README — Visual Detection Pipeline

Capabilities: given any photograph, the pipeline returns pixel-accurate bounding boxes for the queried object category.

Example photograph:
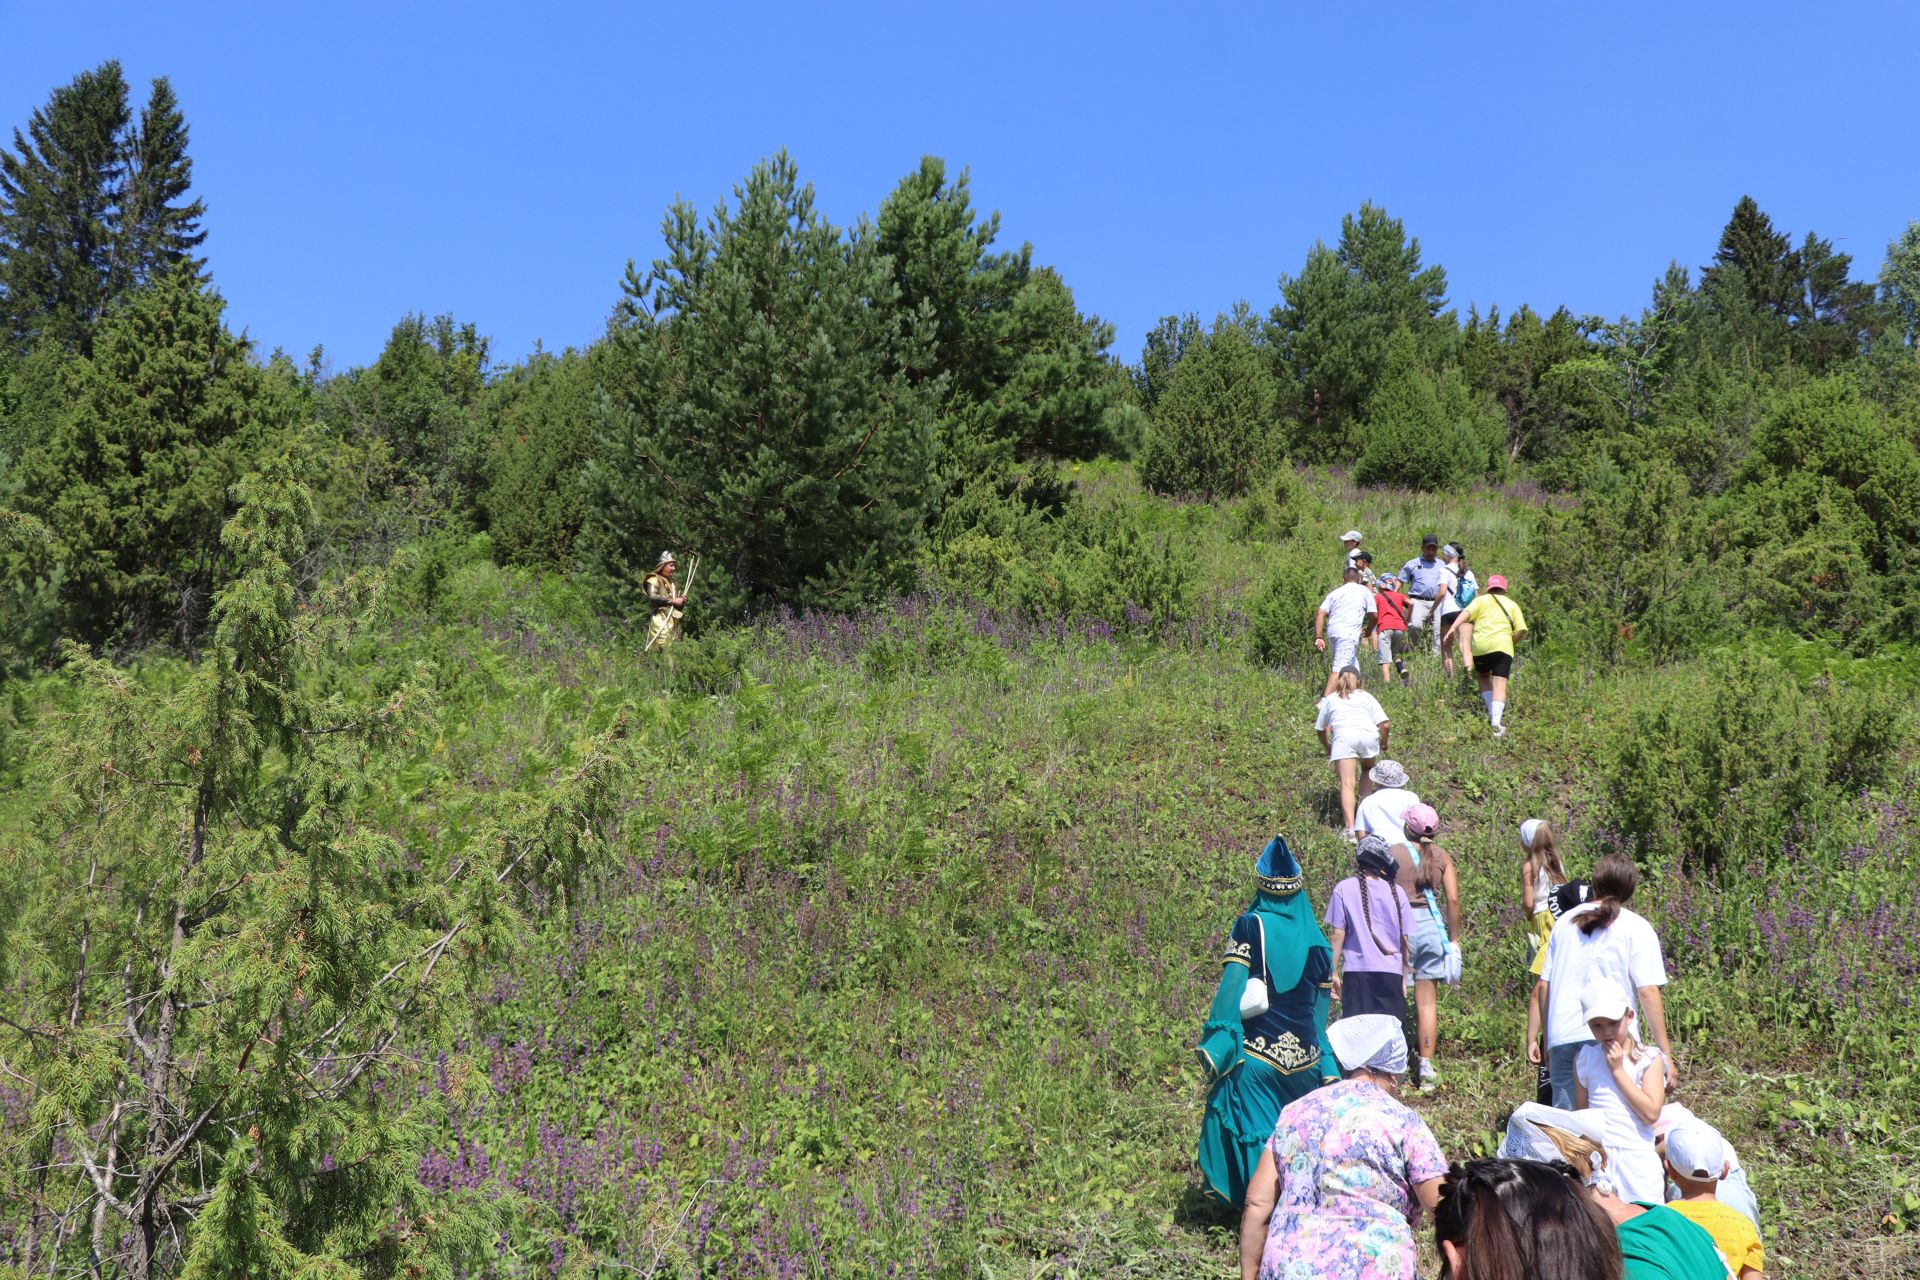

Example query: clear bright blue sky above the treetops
[0,0,1920,368]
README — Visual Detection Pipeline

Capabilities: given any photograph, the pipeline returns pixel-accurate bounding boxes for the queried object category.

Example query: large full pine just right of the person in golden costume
[588,152,945,618]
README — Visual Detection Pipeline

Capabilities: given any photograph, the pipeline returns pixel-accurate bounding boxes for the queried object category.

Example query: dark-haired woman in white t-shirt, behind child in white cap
[1526,854,1678,1111]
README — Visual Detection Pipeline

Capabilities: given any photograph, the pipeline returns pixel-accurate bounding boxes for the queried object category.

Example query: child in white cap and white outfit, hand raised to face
[1572,977,1667,1205]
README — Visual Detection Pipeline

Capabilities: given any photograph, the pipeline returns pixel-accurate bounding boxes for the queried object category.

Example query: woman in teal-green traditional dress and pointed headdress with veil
[1194,835,1340,1207]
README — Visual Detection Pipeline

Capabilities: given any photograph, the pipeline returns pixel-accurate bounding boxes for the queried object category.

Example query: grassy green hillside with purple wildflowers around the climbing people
[0,468,1920,1276]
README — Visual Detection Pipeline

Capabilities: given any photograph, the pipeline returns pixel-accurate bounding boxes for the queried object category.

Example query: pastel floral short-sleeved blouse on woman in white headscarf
[1260,1080,1446,1280]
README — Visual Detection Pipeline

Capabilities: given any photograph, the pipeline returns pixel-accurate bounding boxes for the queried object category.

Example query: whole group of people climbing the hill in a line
[1198,530,1763,1280]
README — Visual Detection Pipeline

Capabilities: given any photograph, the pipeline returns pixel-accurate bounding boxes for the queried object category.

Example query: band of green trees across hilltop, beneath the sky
[0,63,1920,664]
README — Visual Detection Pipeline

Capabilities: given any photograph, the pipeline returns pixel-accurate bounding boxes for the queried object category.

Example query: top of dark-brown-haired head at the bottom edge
[1434,1159,1620,1280]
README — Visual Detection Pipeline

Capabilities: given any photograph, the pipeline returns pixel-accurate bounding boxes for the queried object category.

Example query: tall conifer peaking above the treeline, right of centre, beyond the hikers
[1269,203,1452,449]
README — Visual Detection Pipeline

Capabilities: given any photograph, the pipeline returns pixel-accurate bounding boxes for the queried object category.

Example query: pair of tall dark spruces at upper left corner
[0,61,205,353]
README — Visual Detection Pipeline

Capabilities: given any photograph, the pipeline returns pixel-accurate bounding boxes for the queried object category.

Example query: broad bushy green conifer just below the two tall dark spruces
[19,265,298,645]
